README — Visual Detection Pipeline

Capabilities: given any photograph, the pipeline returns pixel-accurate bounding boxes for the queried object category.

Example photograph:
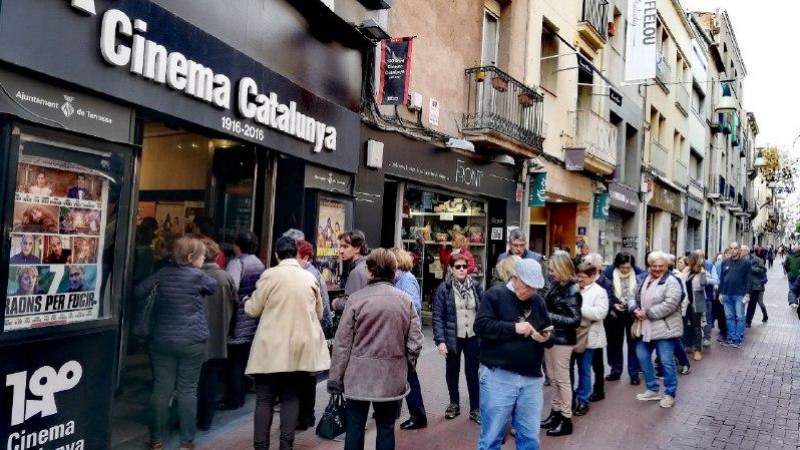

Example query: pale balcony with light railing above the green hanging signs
[564,109,618,175]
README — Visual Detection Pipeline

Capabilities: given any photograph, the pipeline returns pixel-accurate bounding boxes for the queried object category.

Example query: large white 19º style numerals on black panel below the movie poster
[6,361,83,426]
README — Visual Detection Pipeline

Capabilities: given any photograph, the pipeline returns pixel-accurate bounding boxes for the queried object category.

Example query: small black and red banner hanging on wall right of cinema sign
[378,37,414,105]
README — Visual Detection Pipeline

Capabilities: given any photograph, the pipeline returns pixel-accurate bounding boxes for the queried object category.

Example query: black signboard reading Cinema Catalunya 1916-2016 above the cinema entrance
[0,0,360,173]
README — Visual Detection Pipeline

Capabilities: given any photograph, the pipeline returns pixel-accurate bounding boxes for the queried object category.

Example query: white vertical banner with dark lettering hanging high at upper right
[625,0,658,81]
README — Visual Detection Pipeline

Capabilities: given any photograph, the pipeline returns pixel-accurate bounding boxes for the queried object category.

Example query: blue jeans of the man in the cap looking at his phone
[478,366,548,450]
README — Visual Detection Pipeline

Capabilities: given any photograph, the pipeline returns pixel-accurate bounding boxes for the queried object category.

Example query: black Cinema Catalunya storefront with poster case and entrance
[0,0,369,449]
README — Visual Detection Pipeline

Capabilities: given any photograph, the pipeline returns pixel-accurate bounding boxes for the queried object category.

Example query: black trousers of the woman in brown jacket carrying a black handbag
[344,400,401,450]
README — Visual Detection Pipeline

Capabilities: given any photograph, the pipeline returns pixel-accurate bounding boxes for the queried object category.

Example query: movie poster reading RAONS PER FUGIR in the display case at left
[4,160,108,331]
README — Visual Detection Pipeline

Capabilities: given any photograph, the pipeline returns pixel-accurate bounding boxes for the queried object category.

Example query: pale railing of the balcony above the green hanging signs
[569,109,618,166]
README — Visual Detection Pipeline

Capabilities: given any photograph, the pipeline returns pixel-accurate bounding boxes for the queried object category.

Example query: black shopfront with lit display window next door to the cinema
[355,126,520,318]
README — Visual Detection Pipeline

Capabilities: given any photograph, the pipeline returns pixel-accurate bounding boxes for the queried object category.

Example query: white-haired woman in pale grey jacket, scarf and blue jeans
[632,251,683,408]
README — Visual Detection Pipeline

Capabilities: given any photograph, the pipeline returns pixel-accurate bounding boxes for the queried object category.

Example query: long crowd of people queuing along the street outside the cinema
[134,215,780,450]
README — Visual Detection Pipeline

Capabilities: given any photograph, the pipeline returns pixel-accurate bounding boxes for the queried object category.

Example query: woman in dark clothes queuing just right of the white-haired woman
[683,254,708,361]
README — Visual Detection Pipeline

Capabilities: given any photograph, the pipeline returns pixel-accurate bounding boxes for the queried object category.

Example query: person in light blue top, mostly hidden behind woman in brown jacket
[389,247,428,430]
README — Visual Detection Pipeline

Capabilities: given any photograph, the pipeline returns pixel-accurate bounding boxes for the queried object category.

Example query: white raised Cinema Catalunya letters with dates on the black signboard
[93,9,336,153]
